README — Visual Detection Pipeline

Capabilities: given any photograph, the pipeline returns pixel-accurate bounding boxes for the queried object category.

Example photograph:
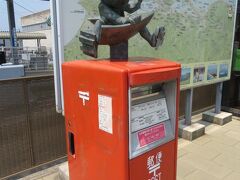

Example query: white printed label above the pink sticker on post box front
[131,98,169,132]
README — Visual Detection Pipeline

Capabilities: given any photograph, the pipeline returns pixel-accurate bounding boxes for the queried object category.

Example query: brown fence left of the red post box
[0,76,66,179]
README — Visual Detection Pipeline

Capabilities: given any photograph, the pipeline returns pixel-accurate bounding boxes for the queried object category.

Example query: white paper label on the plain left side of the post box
[98,95,113,134]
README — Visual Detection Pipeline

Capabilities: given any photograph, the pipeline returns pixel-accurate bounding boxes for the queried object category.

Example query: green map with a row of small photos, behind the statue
[64,0,237,88]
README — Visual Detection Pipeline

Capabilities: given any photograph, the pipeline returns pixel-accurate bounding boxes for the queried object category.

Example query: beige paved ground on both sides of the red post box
[20,117,240,180]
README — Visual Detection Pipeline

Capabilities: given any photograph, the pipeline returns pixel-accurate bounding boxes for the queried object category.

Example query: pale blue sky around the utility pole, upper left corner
[0,0,50,31]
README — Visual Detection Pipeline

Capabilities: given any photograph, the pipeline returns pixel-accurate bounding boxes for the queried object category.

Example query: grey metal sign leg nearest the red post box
[185,88,193,125]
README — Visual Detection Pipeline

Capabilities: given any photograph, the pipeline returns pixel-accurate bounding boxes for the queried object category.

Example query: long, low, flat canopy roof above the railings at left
[0,32,47,39]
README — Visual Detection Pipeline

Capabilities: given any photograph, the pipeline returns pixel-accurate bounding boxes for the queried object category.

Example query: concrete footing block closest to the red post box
[178,120,205,141]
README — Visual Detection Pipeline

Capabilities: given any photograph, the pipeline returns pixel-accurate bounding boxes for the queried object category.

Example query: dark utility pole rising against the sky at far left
[7,0,18,64]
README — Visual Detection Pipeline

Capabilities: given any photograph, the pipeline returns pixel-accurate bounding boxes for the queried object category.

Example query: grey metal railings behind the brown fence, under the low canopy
[0,46,53,71]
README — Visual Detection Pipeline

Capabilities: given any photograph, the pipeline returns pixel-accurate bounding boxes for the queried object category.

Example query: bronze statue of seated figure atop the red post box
[80,0,165,59]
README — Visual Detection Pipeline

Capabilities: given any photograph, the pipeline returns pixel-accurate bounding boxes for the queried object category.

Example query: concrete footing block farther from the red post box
[202,111,232,126]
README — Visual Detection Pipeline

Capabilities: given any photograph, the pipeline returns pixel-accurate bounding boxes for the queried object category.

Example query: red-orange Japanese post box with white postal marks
[62,58,180,180]
